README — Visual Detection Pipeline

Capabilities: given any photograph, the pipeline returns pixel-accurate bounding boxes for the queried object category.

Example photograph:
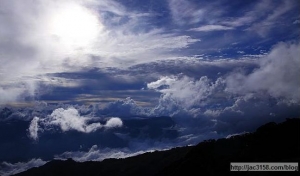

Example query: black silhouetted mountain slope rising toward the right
[16,118,300,176]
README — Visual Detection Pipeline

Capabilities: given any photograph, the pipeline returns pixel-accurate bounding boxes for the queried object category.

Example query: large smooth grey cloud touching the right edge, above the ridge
[226,43,300,102]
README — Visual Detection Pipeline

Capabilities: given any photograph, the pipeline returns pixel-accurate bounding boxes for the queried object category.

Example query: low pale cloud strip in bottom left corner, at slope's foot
[0,159,47,176]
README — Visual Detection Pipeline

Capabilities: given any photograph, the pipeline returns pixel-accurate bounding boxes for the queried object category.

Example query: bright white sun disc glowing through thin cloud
[48,4,103,49]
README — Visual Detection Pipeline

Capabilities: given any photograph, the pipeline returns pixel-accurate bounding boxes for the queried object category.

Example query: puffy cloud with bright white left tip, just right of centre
[147,76,224,108]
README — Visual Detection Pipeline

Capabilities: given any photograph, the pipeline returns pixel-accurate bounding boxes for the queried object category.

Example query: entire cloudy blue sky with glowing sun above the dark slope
[0,0,300,175]
